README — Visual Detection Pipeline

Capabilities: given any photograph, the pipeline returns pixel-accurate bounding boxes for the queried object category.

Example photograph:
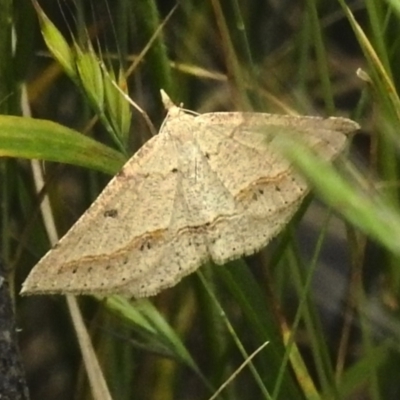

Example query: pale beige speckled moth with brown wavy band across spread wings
[22,94,359,298]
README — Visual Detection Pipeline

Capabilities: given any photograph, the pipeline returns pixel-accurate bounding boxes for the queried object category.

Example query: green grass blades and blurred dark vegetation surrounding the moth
[0,0,400,400]
